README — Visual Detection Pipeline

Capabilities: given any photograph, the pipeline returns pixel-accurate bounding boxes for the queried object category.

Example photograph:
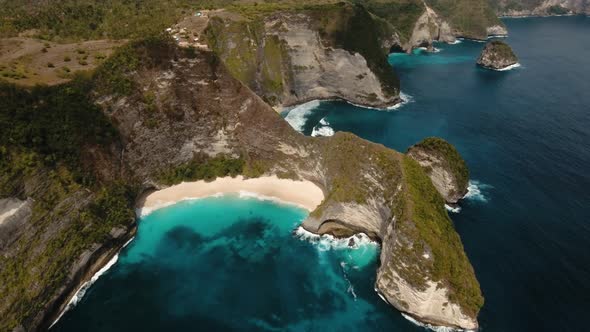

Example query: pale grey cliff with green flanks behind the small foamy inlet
[207,4,399,108]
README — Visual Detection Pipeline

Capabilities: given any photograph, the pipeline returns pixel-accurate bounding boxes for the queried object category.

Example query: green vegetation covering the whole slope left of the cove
[0,38,153,331]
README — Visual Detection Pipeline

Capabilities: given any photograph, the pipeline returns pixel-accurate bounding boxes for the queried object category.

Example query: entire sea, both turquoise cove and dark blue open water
[54,17,590,332]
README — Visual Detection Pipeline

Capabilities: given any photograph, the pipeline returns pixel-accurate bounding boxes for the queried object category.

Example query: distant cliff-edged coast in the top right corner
[489,0,590,17]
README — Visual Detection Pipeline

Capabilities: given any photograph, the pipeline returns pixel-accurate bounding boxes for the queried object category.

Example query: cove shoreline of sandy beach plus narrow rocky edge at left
[41,175,324,330]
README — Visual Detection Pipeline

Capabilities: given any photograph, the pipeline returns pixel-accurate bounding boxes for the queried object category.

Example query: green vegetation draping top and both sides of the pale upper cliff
[206,2,399,105]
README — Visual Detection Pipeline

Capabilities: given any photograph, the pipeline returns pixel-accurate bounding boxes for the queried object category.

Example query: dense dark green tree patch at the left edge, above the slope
[0,76,117,179]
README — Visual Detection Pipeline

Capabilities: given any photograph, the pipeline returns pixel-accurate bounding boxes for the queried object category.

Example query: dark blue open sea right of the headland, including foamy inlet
[284,17,590,331]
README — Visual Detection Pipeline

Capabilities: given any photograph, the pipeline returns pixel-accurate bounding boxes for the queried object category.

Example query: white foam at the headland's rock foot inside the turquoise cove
[294,226,379,251]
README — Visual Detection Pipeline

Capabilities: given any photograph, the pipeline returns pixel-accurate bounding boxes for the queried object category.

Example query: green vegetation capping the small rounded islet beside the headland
[410,137,469,188]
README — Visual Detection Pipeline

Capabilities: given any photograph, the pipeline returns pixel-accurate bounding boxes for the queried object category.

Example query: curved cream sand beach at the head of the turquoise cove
[137,176,324,216]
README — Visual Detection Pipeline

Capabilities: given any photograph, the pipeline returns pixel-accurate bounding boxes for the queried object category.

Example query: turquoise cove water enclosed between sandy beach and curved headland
[53,196,416,331]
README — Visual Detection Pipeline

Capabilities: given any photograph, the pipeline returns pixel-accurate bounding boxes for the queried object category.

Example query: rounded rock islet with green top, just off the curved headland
[407,137,469,204]
